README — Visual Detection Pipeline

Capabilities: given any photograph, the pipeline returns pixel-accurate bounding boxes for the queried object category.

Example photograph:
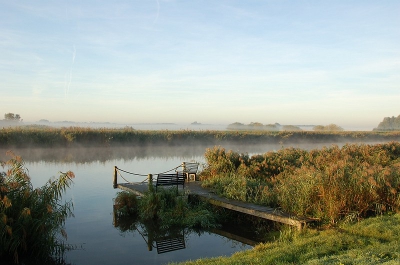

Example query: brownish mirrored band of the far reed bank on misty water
[0,143,344,163]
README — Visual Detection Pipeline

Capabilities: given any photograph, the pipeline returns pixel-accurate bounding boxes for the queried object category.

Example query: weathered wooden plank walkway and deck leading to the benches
[117,181,312,230]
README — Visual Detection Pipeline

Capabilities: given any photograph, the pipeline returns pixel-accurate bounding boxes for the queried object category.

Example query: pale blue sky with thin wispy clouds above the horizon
[0,0,400,130]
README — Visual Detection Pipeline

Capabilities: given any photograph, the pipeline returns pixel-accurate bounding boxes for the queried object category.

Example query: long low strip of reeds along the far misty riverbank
[0,127,400,147]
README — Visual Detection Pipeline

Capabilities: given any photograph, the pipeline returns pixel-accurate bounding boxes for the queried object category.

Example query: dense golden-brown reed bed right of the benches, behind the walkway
[201,142,400,223]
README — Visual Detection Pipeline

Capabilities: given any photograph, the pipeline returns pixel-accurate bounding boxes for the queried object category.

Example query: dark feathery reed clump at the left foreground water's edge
[0,152,74,264]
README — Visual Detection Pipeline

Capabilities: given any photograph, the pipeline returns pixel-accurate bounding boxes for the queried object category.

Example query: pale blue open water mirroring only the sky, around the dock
[21,157,251,264]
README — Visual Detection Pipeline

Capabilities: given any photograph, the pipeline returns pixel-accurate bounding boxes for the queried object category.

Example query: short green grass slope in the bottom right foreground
[174,214,400,265]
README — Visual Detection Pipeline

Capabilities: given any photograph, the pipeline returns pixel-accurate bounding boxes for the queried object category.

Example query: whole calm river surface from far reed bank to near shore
[0,143,340,265]
